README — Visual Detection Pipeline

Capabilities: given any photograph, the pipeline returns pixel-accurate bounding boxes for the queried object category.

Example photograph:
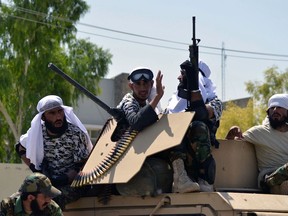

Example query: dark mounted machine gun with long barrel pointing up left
[48,63,128,141]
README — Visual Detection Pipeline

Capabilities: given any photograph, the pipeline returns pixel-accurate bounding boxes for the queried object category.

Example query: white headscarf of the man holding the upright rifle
[166,60,216,113]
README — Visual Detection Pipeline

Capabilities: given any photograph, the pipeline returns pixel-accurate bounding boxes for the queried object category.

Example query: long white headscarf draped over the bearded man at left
[20,95,92,170]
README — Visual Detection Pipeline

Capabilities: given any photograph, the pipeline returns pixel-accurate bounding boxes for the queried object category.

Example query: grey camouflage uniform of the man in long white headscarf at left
[41,123,89,209]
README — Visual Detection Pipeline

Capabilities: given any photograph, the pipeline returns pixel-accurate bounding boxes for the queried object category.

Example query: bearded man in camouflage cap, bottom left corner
[0,173,63,216]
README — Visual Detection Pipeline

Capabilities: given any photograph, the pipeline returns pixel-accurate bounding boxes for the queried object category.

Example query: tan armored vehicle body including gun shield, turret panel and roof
[65,113,288,216]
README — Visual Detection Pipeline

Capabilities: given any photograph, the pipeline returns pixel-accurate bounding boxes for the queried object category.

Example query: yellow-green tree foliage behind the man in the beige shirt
[217,67,288,139]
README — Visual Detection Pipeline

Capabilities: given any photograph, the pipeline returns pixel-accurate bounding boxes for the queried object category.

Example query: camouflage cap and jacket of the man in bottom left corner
[0,173,63,216]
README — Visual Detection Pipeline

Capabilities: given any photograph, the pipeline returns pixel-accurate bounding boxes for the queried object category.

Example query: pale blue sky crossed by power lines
[77,0,288,107]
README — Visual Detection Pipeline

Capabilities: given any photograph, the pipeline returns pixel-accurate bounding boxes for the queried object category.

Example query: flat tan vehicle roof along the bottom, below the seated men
[65,192,288,216]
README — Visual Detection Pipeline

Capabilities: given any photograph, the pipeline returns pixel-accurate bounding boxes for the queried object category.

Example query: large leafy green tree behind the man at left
[0,0,112,162]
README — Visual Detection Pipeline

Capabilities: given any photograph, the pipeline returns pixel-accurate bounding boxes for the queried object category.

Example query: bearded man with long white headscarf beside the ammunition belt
[16,95,92,209]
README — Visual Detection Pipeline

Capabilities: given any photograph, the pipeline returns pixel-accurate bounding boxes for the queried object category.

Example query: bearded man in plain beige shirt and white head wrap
[228,94,288,195]
